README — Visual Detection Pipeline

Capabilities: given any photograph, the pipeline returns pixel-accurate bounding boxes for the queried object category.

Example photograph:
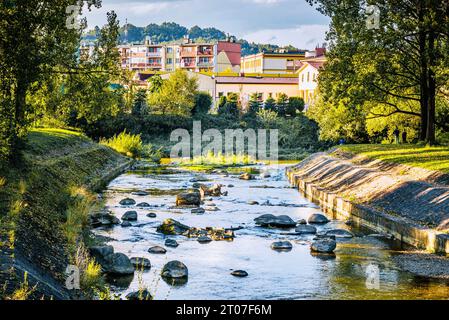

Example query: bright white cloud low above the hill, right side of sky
[242,25,329,50]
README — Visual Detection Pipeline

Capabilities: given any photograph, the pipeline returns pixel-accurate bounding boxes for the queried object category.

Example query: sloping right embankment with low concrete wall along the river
[287,150,449,253]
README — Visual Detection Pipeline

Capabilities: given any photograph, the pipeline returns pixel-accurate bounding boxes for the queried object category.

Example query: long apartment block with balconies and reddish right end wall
[118,39,241,72]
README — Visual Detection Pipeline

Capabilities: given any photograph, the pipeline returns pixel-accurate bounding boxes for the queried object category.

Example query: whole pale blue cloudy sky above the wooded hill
[86,0,329,49]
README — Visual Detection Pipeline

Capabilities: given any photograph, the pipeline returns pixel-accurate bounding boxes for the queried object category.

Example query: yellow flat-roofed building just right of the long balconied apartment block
[241,49,306,74]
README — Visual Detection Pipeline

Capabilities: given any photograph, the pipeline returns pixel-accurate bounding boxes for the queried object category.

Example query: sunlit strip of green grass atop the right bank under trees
[339,144,449,173]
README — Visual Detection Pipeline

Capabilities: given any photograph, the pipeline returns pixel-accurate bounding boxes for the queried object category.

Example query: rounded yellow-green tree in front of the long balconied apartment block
[148,69,198,116]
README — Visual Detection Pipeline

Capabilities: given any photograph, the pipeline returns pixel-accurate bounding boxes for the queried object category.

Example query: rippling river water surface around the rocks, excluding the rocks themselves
[95,165,449,300]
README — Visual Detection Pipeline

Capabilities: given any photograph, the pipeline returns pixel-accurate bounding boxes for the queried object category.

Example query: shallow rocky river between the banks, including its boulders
[92,165,449,300]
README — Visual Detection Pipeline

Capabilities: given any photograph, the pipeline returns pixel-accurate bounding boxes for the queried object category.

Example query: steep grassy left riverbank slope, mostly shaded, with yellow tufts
[0,129,130,299]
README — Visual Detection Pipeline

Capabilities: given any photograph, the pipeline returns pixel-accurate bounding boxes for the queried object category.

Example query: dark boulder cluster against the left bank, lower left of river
[89,246,134,276]
